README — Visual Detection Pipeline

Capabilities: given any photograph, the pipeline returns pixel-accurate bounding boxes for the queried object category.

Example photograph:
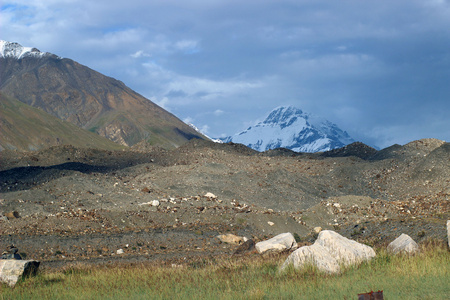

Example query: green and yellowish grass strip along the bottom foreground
[0,247,450,299]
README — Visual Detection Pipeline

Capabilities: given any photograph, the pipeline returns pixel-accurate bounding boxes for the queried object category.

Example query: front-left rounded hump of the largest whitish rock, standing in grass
[280,244,340,273]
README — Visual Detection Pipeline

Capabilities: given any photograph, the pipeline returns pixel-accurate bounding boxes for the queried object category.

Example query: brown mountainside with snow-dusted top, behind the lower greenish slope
[0,41,204,148]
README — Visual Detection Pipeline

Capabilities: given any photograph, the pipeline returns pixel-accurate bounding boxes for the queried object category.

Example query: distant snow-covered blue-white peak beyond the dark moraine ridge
[224,106,354,152]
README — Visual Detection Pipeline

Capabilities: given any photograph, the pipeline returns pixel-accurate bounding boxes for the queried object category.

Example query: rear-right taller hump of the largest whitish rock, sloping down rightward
[315,230,376,265]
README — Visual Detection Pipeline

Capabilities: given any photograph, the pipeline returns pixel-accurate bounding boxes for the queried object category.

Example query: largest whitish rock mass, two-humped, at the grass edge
[280,230,376,273]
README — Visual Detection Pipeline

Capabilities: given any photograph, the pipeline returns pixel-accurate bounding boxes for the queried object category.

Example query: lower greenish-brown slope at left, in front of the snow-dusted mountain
[0,92,124,151]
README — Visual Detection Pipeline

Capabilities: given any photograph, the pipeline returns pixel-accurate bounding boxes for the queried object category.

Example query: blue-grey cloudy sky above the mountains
[0,0,450,148]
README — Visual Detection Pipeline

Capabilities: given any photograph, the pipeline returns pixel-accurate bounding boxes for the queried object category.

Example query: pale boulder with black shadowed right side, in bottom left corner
[0,259,40,287]
